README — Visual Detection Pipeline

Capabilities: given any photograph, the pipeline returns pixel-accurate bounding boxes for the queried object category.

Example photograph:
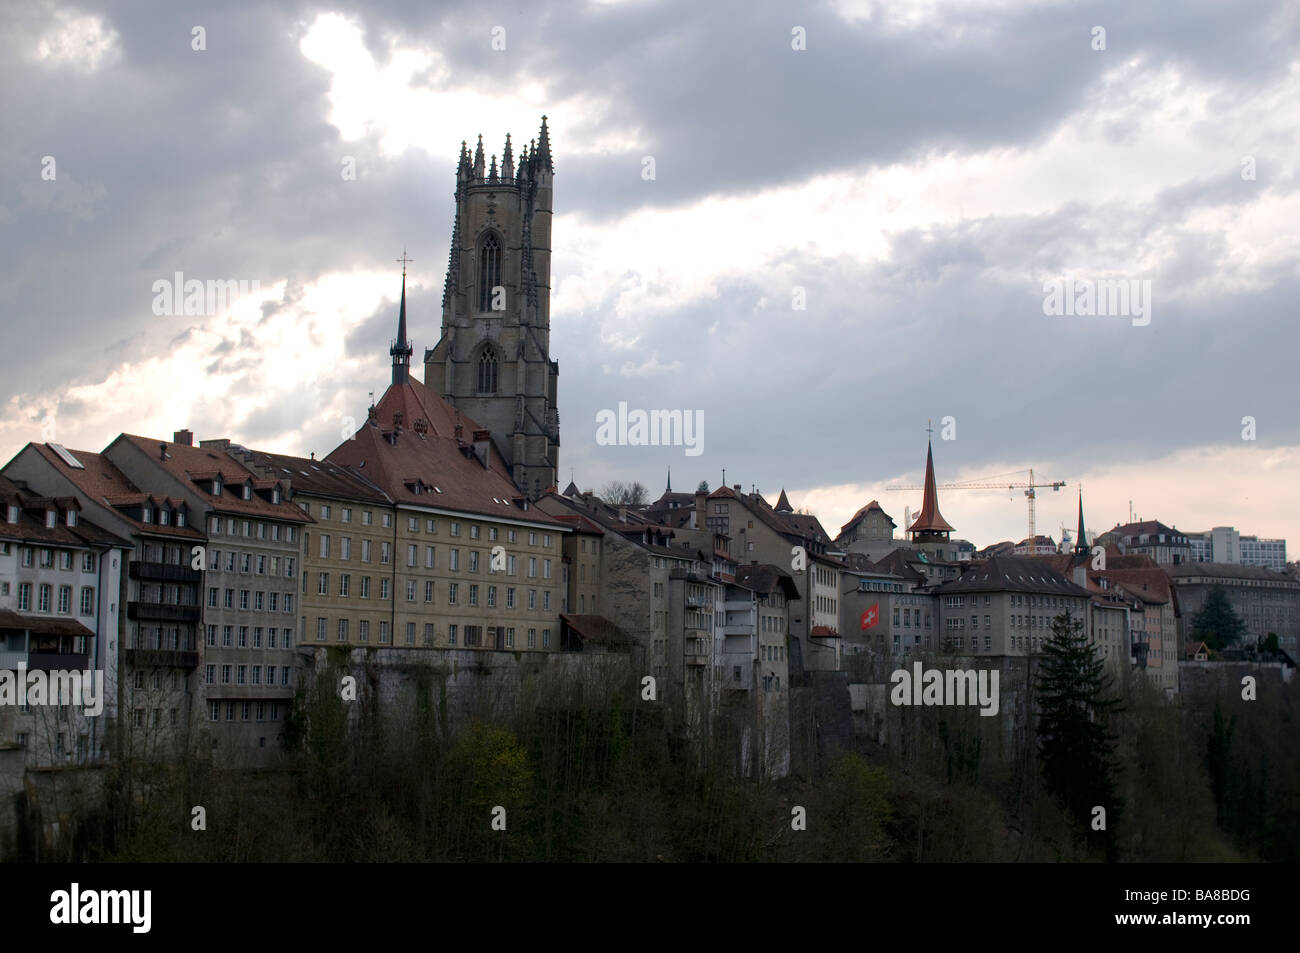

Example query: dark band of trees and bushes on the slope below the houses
[17,639,1300,862]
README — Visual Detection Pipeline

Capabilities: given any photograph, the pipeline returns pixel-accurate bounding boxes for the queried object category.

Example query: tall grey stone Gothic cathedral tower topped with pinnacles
[424,116,560,499]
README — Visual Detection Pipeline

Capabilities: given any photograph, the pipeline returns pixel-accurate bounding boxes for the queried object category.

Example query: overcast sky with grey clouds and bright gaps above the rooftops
[0,0,1300,556]
